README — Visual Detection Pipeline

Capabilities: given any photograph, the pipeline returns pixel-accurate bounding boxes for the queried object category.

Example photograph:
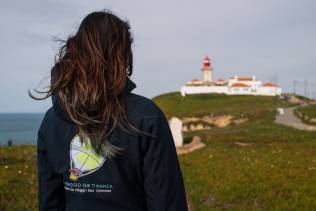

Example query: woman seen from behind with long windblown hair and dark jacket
[29,11,187,211]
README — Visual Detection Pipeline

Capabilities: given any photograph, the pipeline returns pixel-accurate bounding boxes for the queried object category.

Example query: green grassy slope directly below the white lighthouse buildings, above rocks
[153,92,290,117]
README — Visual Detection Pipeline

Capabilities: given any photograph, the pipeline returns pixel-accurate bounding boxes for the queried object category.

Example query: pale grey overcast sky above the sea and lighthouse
[0,0,316,112]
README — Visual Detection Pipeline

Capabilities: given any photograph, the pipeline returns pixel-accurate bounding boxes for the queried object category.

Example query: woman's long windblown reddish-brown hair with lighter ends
[29,10,148,158]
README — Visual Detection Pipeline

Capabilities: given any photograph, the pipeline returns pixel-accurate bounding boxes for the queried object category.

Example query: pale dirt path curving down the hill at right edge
[274,107,316,131]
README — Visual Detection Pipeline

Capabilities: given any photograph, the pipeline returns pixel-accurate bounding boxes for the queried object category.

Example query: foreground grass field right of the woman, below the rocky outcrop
[180,116,316,210]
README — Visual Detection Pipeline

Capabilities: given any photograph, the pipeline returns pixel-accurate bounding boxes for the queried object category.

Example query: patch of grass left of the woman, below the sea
[0,145,37,211]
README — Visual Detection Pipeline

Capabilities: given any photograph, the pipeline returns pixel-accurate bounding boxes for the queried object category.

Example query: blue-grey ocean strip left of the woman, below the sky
[0,113,44,145]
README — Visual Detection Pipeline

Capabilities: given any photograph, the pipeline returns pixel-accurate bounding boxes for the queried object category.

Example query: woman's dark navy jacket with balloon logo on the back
[37,74,188,211]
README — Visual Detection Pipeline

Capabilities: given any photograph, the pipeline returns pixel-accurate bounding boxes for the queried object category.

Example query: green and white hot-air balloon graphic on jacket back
[69,135,105,181]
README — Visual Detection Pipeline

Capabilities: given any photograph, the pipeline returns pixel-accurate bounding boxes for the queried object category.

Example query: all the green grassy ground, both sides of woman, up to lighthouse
[0,92,316,211]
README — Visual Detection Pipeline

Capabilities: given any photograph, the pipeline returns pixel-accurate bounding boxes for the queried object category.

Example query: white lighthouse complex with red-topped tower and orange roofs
[180,56,282,96]
